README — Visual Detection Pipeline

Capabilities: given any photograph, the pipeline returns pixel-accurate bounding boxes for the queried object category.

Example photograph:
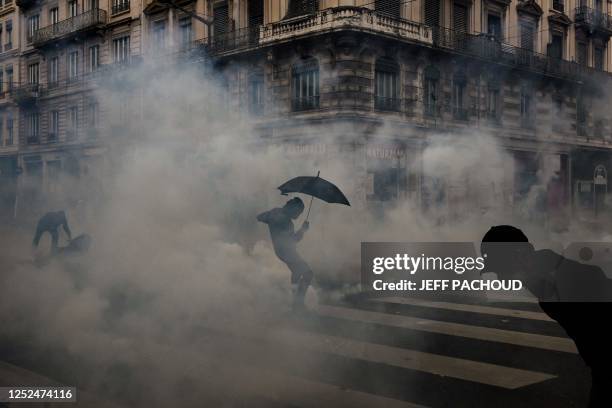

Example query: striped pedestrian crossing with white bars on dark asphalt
[0,297,588,408]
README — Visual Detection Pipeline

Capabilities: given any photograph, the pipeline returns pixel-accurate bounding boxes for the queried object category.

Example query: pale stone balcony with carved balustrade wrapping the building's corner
[259,6,431,45]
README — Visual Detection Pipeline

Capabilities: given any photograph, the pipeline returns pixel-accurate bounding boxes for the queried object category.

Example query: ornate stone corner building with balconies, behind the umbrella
[203,0,612,223]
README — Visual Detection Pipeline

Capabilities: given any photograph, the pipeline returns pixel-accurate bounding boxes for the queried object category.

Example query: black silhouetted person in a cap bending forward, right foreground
[481,225,612,408]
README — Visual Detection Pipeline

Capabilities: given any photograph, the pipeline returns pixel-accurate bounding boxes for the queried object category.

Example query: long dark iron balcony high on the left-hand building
[32,9,106,47]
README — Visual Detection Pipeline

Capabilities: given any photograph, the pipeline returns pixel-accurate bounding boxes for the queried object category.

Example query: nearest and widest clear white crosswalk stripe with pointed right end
[274,329,555,389]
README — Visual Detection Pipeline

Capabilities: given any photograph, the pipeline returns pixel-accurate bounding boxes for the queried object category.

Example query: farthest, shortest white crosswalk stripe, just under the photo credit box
[371,297,554,322]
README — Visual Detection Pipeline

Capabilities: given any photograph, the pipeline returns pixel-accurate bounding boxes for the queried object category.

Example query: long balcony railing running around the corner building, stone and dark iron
[206,6,592,79]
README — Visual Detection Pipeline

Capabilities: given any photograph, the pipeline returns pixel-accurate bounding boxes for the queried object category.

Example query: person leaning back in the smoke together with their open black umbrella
[257,173,350,311]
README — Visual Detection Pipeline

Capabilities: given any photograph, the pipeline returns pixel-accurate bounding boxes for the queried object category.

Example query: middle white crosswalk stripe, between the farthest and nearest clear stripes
[317,305,578,354]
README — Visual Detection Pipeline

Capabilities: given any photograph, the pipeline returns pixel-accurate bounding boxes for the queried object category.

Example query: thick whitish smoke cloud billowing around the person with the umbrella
[0,59,604,406]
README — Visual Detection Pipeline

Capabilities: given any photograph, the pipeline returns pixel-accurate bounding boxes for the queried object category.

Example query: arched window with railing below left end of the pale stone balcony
[291,58,319,111]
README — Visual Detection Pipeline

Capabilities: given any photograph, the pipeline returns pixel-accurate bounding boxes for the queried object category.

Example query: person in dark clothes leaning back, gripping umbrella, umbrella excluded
[257,197,312,310]
